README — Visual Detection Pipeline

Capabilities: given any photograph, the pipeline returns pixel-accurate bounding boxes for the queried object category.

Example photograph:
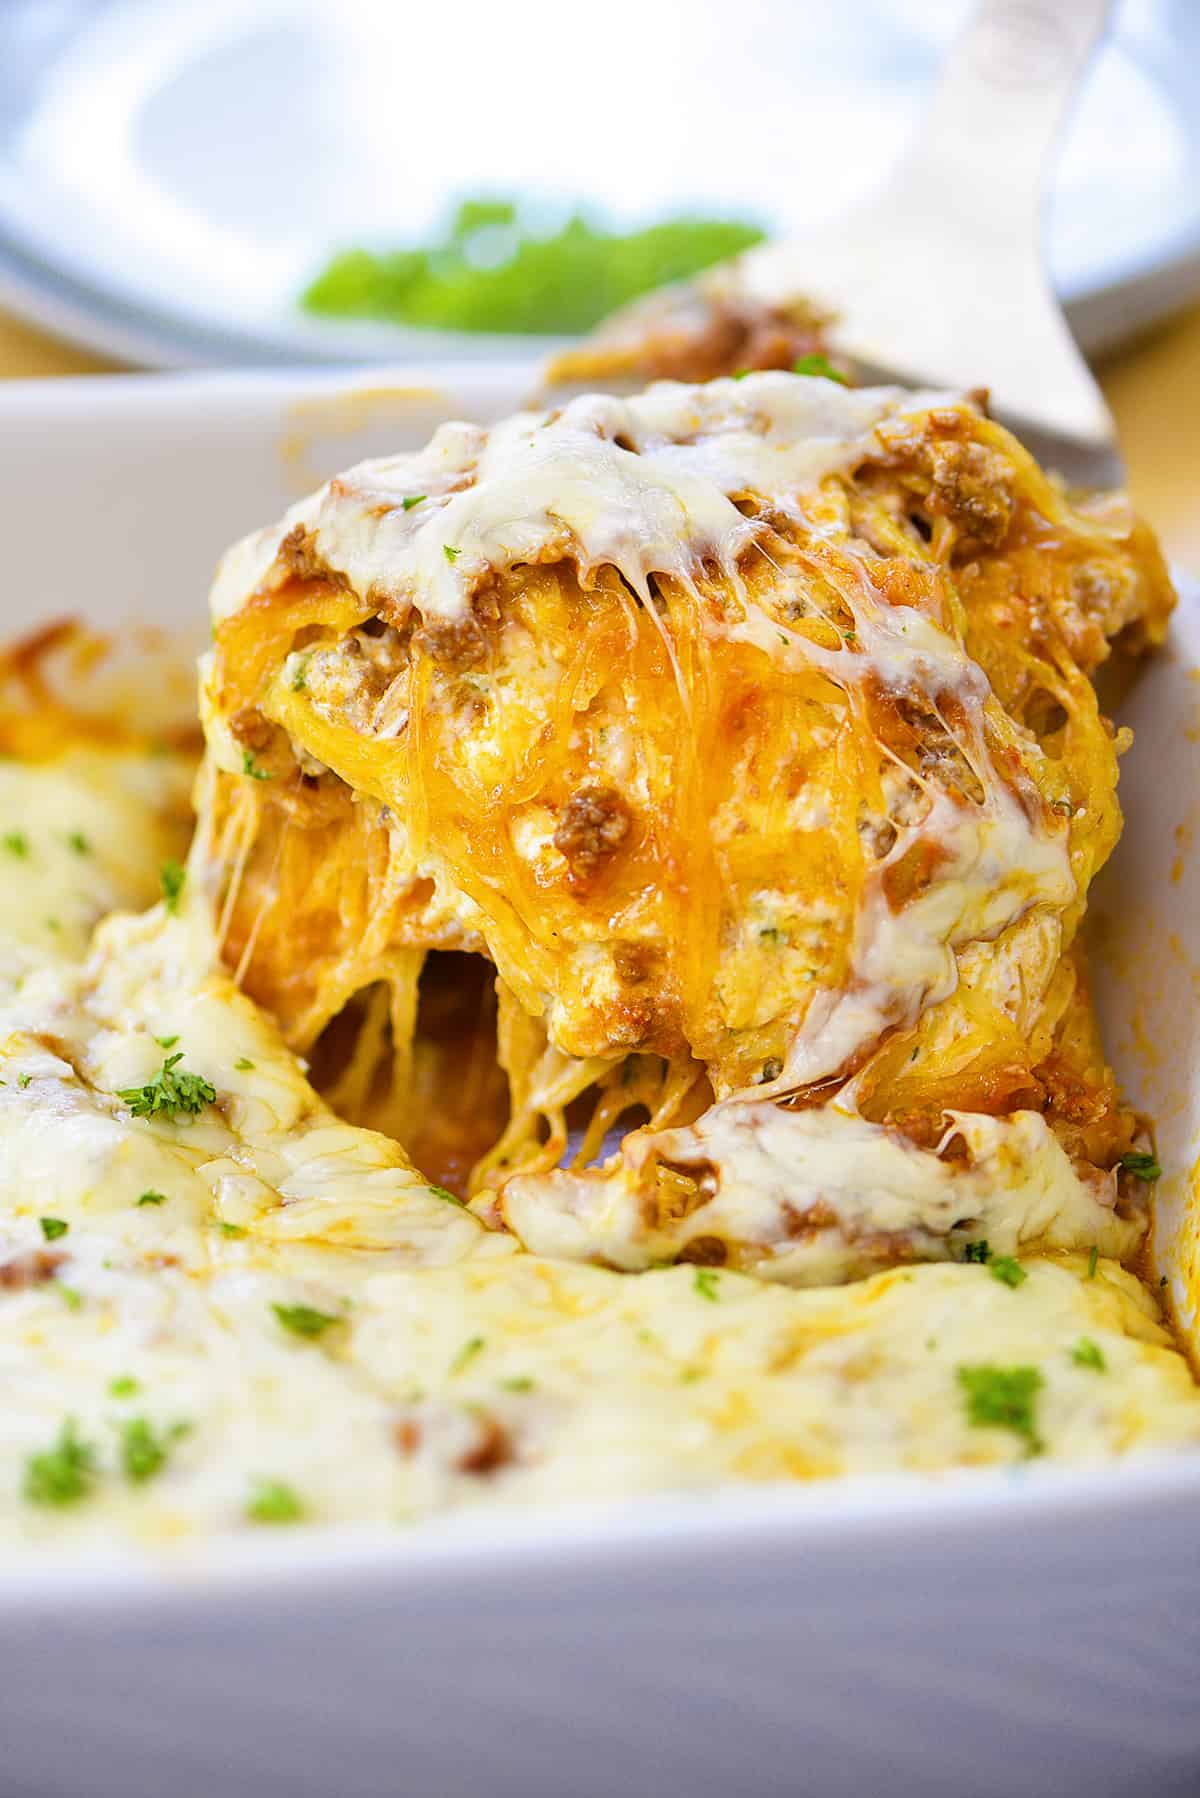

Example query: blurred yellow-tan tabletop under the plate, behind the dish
[0,306,1200,574]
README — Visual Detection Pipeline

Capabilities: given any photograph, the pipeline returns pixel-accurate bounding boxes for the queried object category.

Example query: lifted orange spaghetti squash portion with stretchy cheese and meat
[197,376,1169,1201]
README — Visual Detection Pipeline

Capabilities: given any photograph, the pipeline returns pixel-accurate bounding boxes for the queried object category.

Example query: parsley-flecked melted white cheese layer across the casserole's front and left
[0,744,1200,1555]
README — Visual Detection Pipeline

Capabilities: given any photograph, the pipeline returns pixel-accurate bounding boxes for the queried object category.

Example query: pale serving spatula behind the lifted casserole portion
[719,0,1124,487]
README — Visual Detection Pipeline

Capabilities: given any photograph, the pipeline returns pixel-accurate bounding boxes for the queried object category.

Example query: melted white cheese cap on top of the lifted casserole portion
[212,374,948,620]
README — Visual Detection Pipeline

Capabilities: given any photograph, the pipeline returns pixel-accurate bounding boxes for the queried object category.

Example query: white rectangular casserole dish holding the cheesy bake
[0,365,1200,1798]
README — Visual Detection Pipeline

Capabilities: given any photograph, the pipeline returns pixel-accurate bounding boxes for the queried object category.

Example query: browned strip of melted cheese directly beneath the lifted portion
[500,1100,1144,1286]
